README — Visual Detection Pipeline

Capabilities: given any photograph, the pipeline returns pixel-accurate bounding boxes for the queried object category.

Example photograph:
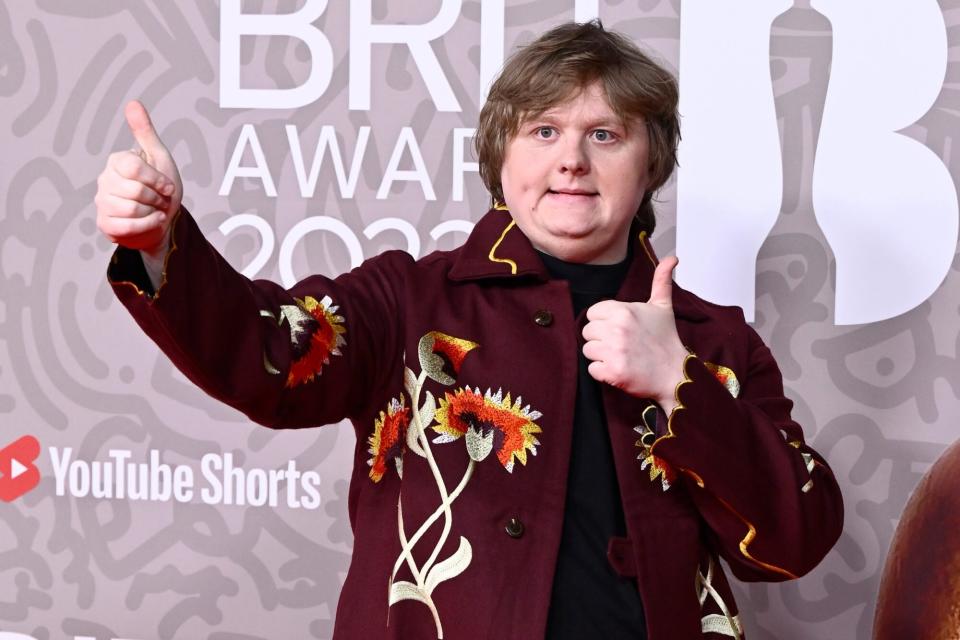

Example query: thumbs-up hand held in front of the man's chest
[583,256,687,415]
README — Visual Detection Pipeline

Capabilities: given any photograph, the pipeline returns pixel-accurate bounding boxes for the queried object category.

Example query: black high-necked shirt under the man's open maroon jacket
[540,253,647,640]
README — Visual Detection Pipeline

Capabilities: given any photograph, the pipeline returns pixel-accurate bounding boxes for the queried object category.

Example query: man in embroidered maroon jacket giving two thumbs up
[97,22,843,640]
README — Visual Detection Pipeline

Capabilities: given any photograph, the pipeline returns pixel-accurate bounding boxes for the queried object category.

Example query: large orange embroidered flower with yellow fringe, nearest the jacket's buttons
[433,387,543,473]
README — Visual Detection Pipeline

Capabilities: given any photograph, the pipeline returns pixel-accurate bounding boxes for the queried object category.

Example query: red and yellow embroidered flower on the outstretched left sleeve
[260,296,347,388]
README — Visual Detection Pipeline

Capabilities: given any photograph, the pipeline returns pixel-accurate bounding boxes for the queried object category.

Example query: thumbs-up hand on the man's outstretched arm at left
[94,100,183,256]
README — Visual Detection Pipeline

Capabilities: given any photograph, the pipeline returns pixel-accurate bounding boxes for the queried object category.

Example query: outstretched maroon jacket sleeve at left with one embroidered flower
[107,209,412,428]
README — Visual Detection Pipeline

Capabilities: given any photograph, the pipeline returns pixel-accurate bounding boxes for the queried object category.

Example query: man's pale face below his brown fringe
[500,83,649,264]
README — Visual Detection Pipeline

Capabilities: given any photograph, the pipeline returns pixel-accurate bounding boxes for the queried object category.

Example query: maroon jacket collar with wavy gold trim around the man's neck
[448,207,708,322]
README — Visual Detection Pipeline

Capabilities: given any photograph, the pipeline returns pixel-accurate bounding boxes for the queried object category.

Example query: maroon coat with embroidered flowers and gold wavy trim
[109,210,843,640]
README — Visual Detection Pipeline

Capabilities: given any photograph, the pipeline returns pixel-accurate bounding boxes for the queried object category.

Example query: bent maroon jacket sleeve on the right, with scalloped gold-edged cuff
[651,327,843,580]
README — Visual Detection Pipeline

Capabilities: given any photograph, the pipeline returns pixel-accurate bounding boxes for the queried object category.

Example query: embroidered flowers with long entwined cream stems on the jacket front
[386,331,541,639]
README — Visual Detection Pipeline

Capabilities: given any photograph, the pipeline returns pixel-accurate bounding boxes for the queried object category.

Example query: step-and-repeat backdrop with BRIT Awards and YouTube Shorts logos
[0,0,960,640]
